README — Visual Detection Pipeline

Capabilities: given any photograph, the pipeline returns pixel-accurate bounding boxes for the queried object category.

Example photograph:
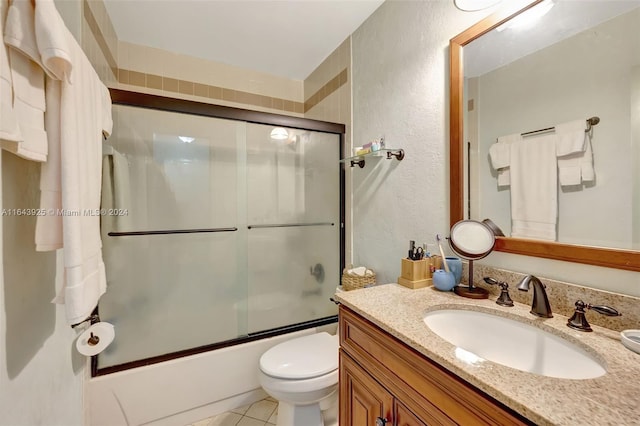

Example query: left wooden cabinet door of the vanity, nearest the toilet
[340,351,393,426]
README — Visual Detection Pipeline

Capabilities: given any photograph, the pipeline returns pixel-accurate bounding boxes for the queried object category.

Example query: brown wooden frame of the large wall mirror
[449,0,640,272]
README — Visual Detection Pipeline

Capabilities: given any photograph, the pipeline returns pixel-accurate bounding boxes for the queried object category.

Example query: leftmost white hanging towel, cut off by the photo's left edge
[0,3,22,145]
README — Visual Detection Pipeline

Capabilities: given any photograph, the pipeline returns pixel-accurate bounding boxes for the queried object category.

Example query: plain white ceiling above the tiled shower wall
[104,0,384,80]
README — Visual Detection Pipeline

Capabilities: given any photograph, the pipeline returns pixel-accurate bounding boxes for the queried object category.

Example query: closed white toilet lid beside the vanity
[260,332,339,379]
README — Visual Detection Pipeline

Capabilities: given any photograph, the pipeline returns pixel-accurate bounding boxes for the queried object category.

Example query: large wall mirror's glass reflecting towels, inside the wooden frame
[464,1,640,250]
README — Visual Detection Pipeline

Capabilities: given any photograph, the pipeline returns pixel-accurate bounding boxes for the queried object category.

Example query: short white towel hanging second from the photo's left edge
[1,0,47,161]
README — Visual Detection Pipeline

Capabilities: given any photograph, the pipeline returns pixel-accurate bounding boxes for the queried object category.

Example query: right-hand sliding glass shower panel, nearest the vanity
[247,124,340,333]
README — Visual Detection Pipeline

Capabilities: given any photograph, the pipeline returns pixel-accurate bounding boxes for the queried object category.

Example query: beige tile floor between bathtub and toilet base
[190,397,278,426]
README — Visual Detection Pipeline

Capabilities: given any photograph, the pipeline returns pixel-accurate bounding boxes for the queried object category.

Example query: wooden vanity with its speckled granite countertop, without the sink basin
[336,284,640,426]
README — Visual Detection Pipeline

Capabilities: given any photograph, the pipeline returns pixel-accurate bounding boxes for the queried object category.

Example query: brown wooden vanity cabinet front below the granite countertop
[339,305,533,426]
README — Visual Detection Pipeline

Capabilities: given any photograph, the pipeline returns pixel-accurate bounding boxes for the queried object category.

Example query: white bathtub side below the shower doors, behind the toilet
[86,324,336,426]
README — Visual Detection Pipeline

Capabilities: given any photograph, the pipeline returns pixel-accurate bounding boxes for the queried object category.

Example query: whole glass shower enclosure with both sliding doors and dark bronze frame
[92,90,344,375]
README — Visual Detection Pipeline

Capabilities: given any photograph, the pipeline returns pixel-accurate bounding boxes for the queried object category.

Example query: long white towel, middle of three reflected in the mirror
[510,134,558,241]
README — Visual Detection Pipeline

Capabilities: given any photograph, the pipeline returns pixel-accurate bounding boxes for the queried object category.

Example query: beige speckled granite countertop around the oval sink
[335,284,640,426]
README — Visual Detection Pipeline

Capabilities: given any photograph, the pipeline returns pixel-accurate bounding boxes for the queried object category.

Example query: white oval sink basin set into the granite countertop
[424,309,606,379]
